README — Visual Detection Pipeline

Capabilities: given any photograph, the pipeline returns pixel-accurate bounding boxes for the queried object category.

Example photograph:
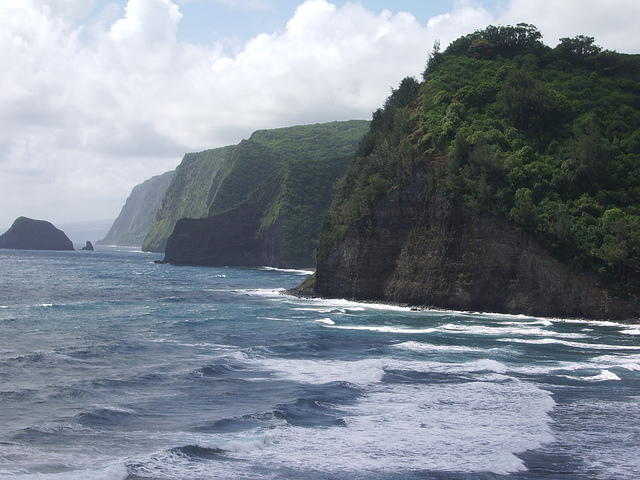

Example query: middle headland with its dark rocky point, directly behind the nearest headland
[160,120,369,267]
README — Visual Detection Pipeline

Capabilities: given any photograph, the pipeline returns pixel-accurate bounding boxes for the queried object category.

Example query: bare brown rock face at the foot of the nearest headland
[303,163,640,320]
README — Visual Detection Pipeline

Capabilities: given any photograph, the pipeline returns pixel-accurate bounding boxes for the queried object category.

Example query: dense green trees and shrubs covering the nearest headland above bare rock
[321,24,640,295]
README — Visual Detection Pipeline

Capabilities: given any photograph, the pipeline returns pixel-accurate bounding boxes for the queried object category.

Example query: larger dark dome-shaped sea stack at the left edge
[0,217,73,250]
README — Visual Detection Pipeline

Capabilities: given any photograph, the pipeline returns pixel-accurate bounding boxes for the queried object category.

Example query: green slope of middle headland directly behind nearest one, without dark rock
[228,120,369,262]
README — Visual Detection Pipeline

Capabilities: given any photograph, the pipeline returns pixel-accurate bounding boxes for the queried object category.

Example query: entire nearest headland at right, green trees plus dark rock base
[298,24,640,321]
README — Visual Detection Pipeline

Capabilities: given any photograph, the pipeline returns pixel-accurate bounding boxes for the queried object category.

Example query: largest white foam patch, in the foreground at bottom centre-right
[244,380,554,474]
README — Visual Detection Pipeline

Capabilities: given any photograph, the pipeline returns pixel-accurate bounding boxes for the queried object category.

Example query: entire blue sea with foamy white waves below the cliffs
[0,249,640,480]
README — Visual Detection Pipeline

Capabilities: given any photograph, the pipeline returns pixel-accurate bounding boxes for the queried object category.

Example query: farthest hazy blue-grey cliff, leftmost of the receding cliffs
[97,171,174,247]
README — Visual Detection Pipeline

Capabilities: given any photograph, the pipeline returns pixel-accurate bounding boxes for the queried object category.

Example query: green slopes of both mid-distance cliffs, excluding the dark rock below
[145,120,369,263]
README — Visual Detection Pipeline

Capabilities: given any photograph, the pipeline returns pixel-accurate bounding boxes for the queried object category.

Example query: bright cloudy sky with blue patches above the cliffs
[0,0,640,227]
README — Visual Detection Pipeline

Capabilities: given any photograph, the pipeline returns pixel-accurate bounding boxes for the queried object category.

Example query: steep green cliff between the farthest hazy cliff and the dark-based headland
[142,146,235,252]
